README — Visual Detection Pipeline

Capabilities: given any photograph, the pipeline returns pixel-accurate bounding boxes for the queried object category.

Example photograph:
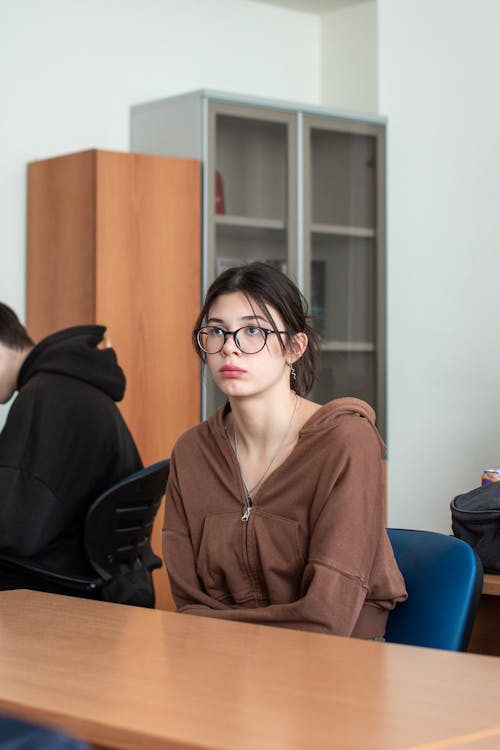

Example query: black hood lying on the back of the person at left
[17,326,125,401]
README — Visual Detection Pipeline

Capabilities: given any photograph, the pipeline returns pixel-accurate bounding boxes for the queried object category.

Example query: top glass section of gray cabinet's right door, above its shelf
[311,128,376,227]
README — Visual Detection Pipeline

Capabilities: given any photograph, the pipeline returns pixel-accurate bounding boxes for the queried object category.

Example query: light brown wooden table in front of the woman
[0,591,500,750]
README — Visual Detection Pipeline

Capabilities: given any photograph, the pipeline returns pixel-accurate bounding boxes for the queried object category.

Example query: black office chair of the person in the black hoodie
[0,459,170,607]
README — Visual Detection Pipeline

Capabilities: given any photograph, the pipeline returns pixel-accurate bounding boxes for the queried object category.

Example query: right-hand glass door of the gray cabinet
[304,116,385,432]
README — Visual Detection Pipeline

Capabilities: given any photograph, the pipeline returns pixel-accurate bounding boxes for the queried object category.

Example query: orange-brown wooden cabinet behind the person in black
[27,150,201,608]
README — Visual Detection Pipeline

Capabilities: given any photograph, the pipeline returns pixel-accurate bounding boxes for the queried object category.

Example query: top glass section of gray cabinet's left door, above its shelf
[215,114,288,223]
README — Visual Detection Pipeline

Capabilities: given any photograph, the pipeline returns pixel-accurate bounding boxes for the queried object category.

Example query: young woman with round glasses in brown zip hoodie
[163,263,406,638]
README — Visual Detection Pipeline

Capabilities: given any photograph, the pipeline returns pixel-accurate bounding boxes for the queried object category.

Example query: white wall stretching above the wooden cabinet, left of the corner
[0,0,320,422]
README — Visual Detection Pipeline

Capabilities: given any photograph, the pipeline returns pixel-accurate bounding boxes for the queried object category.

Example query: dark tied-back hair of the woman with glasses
[193,261,320,396]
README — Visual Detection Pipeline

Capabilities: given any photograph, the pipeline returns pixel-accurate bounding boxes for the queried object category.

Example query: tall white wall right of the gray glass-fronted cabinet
[378,0,500,531]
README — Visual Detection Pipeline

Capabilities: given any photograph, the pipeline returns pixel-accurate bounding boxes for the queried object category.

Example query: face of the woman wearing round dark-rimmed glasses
[207,292,295,398]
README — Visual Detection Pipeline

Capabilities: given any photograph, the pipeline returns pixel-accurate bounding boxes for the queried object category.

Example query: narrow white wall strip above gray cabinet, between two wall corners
[321,0,378,114]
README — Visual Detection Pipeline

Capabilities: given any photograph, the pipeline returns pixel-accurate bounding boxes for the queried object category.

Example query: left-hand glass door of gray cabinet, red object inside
[205,101,297,414]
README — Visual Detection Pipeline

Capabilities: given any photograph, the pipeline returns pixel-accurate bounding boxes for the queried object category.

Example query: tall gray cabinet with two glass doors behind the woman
[131,91,386,433]
